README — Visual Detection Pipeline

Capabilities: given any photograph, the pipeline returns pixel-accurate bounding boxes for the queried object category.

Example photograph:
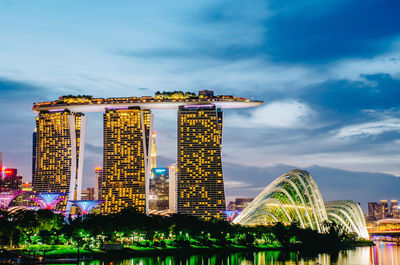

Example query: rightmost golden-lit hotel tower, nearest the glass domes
[177,104,225,219]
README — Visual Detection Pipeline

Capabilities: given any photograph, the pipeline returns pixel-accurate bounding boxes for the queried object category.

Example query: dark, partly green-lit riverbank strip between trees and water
[0,240,374,263]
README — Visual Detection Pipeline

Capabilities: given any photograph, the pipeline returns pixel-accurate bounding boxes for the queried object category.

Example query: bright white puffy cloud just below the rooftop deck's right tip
[224,100,314,128]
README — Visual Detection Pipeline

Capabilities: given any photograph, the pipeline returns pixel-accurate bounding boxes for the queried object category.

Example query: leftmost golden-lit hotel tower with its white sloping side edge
[33,111,86,212]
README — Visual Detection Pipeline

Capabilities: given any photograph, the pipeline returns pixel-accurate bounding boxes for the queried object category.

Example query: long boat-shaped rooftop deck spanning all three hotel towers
[32,91,264,113]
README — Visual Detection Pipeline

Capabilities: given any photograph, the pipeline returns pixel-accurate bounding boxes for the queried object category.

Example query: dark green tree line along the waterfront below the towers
[0,205,357,249]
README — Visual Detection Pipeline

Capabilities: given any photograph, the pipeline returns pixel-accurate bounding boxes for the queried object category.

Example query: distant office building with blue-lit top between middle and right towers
[149,168,169,211]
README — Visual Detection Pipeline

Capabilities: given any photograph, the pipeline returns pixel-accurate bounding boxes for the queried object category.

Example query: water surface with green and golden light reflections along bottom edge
[82,242,400,265]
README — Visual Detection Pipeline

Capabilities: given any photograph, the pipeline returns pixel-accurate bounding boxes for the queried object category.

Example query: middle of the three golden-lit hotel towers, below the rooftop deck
[101,107,153,213]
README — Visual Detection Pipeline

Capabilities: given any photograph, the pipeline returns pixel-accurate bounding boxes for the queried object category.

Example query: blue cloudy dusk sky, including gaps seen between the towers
[0,0,400,209]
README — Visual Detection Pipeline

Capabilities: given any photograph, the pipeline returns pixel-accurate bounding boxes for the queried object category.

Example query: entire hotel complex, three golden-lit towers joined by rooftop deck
[32,90,263,214]
